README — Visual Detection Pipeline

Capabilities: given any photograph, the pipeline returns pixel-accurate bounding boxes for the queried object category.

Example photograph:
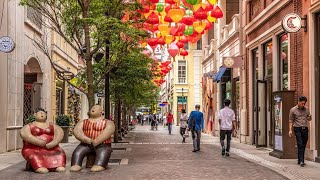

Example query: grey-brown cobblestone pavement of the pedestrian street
[0,126,287,180]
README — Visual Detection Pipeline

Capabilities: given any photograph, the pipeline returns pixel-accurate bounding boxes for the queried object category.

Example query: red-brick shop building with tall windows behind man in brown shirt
[240,0,320,159]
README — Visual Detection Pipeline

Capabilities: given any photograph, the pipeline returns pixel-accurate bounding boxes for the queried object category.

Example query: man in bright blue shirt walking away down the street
[188,105,203,152]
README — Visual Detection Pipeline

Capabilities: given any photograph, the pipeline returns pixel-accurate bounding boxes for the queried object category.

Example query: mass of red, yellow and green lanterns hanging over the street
[126,0,223,86]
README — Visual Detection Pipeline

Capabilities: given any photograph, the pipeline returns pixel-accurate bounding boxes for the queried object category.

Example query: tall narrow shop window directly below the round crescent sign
[279,34,289,90]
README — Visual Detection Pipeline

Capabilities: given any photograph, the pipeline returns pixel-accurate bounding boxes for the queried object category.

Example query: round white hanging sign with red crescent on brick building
[282,13,302,33]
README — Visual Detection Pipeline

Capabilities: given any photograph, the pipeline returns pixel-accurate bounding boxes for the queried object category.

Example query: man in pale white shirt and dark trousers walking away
[219,99,236,156]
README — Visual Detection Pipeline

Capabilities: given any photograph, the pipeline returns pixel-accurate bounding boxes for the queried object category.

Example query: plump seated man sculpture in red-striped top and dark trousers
[70,105,115,172]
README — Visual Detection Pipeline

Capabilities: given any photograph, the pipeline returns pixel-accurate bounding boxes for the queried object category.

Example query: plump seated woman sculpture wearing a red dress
[20,108,66,173]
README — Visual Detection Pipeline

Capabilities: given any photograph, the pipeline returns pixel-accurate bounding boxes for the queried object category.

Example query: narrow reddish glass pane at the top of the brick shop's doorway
[263,41,272,80]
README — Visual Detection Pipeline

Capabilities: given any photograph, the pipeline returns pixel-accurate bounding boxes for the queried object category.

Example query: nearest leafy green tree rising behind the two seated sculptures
[20,0,148,107]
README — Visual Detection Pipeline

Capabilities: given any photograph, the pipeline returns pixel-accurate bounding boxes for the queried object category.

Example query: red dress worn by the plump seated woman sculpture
[21,123,66,170]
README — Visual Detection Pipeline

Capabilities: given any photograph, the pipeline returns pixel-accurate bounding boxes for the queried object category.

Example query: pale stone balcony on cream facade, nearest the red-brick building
[220,14,240,43]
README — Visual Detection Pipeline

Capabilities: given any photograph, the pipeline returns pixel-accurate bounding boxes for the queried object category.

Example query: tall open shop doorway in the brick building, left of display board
[253,41,274,148]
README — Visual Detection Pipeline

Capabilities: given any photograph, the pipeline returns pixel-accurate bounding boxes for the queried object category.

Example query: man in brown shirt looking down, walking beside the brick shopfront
[289,96,311,167]
